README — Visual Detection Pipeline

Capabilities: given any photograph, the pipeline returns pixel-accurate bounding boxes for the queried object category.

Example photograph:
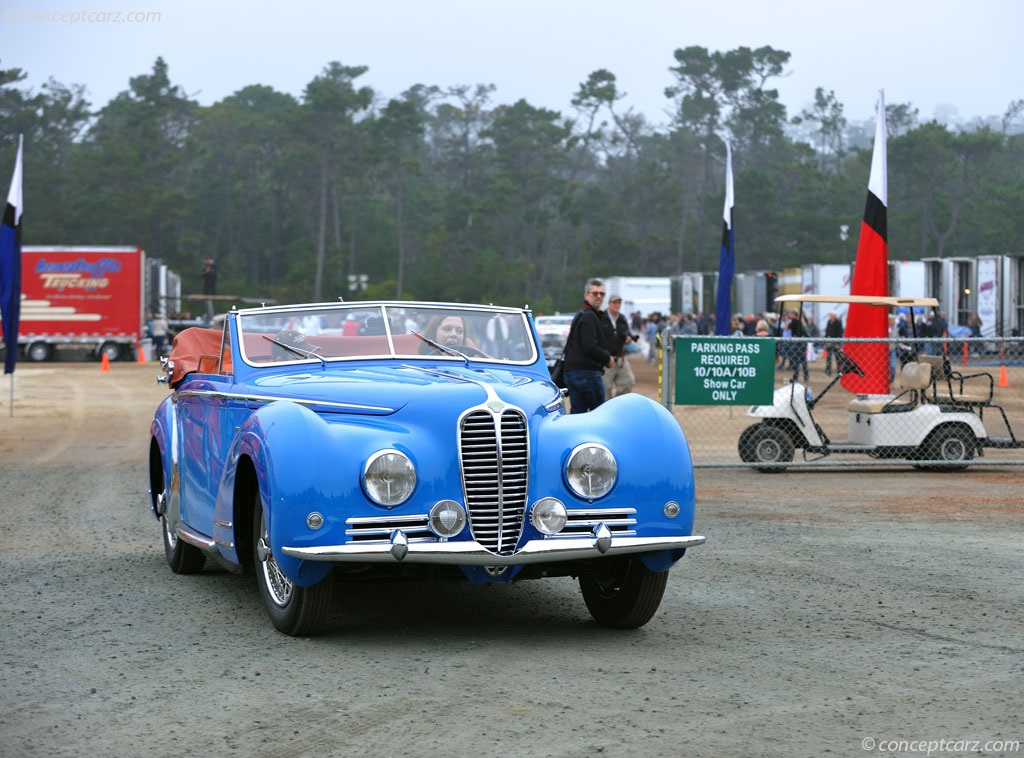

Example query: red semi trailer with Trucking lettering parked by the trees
[0,245,180,362]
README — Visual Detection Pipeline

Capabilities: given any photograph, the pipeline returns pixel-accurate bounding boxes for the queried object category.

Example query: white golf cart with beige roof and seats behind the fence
[738,295,1024,472]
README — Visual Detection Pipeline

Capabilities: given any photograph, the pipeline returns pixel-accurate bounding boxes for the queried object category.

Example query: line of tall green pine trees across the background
[0,46,1024,311]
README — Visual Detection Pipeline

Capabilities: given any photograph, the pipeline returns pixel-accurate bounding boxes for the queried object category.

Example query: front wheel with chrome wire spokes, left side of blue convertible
[253,490,332,637]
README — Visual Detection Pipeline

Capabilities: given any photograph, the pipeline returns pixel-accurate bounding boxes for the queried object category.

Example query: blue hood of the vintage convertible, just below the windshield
[243,365,561,415]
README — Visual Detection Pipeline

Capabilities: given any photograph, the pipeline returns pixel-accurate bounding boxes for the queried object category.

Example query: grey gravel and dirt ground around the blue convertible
[0,363,1024,758]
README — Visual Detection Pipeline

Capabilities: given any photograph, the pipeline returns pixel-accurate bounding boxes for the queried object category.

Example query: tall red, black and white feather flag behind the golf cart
[842,91,890,394]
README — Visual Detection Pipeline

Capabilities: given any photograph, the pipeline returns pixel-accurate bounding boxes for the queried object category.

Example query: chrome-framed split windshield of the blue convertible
[238,303,538,366]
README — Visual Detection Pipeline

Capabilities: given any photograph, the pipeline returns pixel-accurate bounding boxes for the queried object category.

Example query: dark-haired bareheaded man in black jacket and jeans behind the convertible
[564,279,612,413]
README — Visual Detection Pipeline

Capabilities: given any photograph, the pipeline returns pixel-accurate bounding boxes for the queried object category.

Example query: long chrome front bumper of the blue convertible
[282,524,705,565]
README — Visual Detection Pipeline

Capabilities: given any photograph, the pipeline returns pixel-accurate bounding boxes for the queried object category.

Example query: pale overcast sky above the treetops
[0,0,1024,124]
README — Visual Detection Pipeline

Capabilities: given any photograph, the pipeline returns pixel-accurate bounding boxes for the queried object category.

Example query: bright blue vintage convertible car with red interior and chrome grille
[150,302,703,635]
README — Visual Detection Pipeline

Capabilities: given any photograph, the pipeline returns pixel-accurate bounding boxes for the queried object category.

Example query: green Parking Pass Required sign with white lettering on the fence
[676,337,775,406]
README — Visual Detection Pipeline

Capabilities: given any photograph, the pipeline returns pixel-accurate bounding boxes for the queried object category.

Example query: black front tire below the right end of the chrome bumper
[580,558,669,629]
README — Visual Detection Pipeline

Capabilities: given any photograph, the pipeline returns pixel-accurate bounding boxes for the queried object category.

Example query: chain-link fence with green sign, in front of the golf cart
[659,334,1024,471]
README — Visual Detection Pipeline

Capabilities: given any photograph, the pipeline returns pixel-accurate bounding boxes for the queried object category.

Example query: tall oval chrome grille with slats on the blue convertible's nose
[459,409,529,555]
